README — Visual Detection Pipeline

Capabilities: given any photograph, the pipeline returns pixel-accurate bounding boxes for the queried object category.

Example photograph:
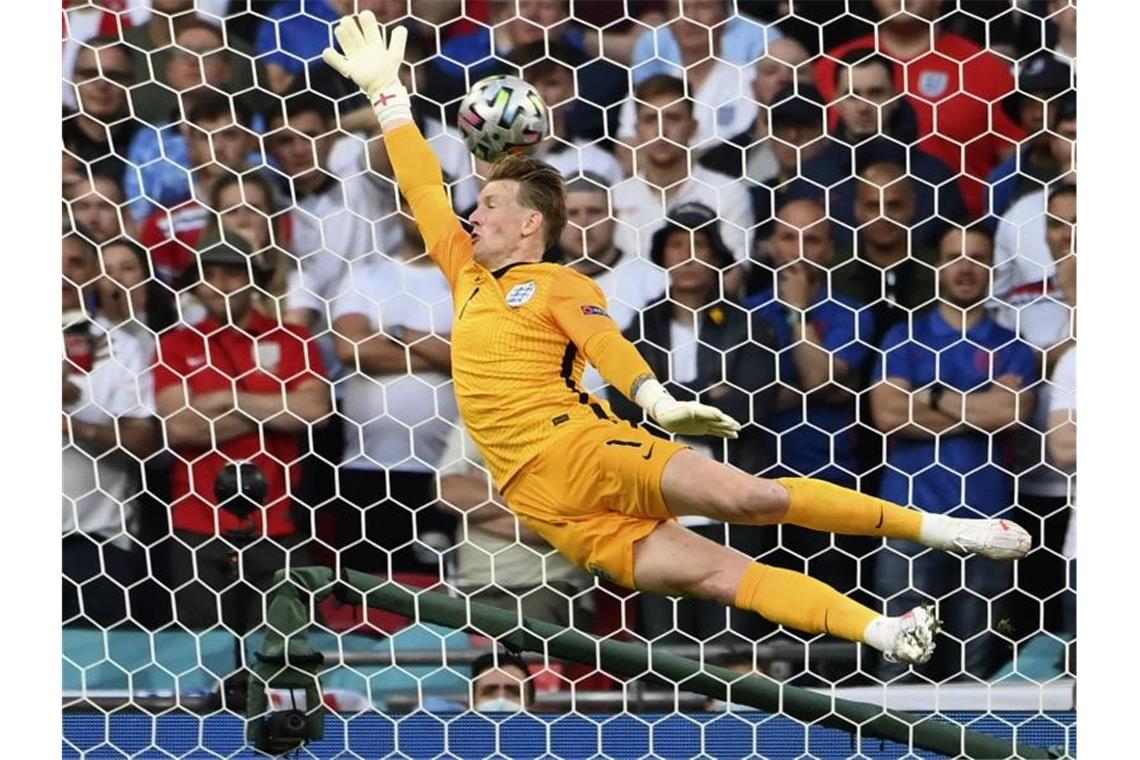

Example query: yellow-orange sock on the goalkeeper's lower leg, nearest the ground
[736,563,879,641]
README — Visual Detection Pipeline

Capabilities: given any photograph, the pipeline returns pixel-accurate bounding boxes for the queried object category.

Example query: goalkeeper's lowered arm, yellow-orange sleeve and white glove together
[551,271,740,438]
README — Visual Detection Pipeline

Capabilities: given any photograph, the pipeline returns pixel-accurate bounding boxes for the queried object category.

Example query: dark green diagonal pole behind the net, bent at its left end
[250,567,1055,760]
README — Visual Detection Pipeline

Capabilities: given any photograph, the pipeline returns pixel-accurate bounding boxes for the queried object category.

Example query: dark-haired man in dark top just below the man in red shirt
[825,48,966,240]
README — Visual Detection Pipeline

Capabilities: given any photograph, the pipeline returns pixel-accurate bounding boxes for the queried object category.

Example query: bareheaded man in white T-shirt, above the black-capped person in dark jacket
[612,75,754,273]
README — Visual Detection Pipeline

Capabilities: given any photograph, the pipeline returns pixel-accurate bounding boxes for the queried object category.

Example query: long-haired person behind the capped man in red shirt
[210,172,295,314]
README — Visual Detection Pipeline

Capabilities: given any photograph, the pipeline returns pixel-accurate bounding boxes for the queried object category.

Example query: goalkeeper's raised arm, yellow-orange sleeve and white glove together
[321,10,471,285]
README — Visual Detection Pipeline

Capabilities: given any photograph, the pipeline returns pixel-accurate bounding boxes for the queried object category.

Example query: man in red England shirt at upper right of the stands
[815,0,1025,216]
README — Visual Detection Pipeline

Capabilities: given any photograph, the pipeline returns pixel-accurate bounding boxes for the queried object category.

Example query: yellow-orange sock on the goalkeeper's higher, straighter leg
[777,477,922,541]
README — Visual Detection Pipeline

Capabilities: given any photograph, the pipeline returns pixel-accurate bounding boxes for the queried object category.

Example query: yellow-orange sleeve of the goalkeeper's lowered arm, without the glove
[549,270,653,395]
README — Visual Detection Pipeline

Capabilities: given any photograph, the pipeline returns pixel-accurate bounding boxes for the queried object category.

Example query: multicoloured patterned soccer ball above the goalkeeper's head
[459,75,549,161]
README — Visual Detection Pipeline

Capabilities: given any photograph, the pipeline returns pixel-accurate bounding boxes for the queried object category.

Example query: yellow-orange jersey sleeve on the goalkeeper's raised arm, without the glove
[384,124,471,288]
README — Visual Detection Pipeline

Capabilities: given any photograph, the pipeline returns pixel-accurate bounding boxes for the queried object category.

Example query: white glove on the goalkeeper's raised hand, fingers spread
[320,10,412,128]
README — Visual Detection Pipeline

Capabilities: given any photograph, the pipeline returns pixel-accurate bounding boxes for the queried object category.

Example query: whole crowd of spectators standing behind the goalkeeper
[62,0,1076,700]
